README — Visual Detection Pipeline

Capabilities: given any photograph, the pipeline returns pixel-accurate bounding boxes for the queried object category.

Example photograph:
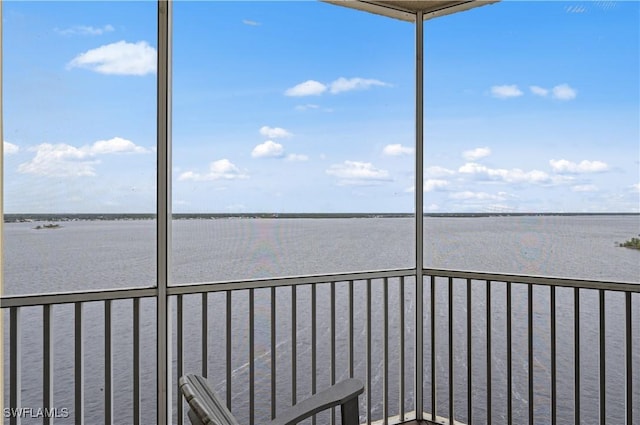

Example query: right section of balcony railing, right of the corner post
[424,269,640,425]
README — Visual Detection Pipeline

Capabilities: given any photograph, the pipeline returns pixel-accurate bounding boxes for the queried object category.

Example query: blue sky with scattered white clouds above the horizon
[2,1,640,213]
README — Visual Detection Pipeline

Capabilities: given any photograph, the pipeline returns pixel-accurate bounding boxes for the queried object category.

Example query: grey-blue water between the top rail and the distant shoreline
[4,216,640,295]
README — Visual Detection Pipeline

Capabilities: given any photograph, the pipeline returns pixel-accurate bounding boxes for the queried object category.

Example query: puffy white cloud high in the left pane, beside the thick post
[67,40,157,75]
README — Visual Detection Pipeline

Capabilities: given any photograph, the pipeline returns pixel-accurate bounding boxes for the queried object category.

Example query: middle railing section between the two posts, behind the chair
[171,269,415,425]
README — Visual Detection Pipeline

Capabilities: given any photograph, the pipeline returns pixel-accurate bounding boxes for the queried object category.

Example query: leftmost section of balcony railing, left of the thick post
[1,288,155,424]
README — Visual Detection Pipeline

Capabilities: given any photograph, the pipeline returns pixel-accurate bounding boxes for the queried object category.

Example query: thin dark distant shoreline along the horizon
[4,212,640,223]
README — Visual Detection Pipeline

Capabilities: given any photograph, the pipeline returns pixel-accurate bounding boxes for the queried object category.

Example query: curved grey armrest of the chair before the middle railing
[268,379,364,425]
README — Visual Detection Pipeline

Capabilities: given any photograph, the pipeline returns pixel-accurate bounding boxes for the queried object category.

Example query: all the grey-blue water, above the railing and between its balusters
[4,216,640,423]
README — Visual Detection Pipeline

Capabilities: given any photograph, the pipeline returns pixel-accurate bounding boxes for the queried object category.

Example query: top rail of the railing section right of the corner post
[423,269,640,293]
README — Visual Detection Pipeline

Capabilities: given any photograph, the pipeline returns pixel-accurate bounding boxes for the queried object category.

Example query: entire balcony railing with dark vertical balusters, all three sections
[2,269,640,425]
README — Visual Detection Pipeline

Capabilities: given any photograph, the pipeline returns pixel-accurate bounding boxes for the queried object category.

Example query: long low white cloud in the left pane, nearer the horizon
[18,137,150,177]
